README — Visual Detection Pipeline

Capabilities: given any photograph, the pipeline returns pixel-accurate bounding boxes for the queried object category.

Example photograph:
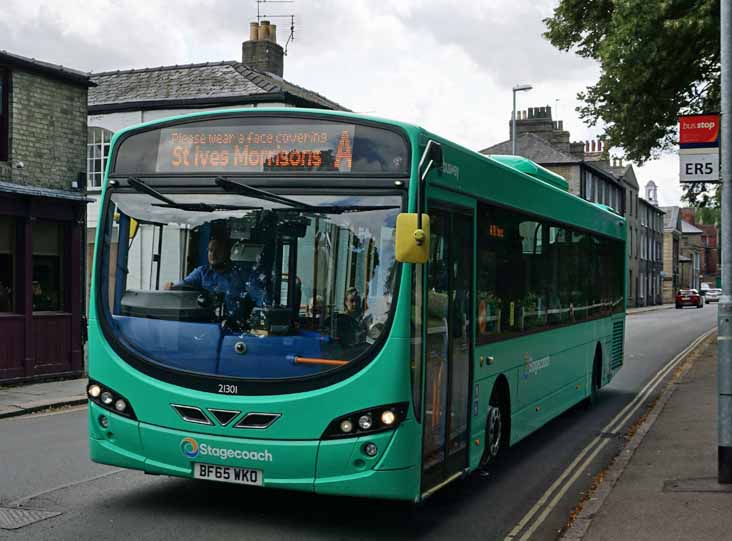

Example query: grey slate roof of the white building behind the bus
[89,60,348,114]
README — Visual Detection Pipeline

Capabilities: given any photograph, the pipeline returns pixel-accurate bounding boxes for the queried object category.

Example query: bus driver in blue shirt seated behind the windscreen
[163,237,248,319]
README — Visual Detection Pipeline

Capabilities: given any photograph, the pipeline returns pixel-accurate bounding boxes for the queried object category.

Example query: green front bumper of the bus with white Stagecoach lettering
[89,403,419,501]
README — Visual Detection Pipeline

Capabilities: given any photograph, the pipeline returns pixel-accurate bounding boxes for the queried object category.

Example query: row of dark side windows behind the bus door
[476,200,623,344]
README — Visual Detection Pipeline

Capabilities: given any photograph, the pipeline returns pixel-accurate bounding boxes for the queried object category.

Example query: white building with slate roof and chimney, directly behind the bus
[86,21,348,298]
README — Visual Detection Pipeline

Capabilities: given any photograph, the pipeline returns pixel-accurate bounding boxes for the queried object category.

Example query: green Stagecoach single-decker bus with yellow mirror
[88,109,625,502]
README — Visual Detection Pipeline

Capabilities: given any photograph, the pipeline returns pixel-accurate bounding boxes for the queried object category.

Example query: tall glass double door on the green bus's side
[422,201,474,493]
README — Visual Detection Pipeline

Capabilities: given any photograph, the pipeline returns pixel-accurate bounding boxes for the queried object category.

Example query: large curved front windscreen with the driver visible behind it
[110,194,398,377]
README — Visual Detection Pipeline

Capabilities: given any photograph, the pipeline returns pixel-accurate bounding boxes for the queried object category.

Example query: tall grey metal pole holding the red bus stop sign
[717,1,732,484]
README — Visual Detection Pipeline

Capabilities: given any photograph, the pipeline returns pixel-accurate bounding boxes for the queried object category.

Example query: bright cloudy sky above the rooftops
[0,0,681,205]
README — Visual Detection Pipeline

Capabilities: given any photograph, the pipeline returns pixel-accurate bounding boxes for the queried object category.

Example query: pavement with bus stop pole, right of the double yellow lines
[562,334,732,541]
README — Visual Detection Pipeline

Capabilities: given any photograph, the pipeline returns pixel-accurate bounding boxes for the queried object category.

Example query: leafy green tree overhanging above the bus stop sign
[544,0,721,201]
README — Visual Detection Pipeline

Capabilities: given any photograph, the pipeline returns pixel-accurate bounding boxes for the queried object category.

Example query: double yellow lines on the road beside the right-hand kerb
[504,327,716,541]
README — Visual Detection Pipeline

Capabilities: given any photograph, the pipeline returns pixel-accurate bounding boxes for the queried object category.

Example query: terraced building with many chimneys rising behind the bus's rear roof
[480,106,661,306]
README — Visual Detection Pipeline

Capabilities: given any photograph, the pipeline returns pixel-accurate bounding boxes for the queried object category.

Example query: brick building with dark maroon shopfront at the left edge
[0,51,93,383]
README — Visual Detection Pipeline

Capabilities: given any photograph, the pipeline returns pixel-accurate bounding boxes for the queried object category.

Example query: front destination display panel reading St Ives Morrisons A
[113,116,409,176]
